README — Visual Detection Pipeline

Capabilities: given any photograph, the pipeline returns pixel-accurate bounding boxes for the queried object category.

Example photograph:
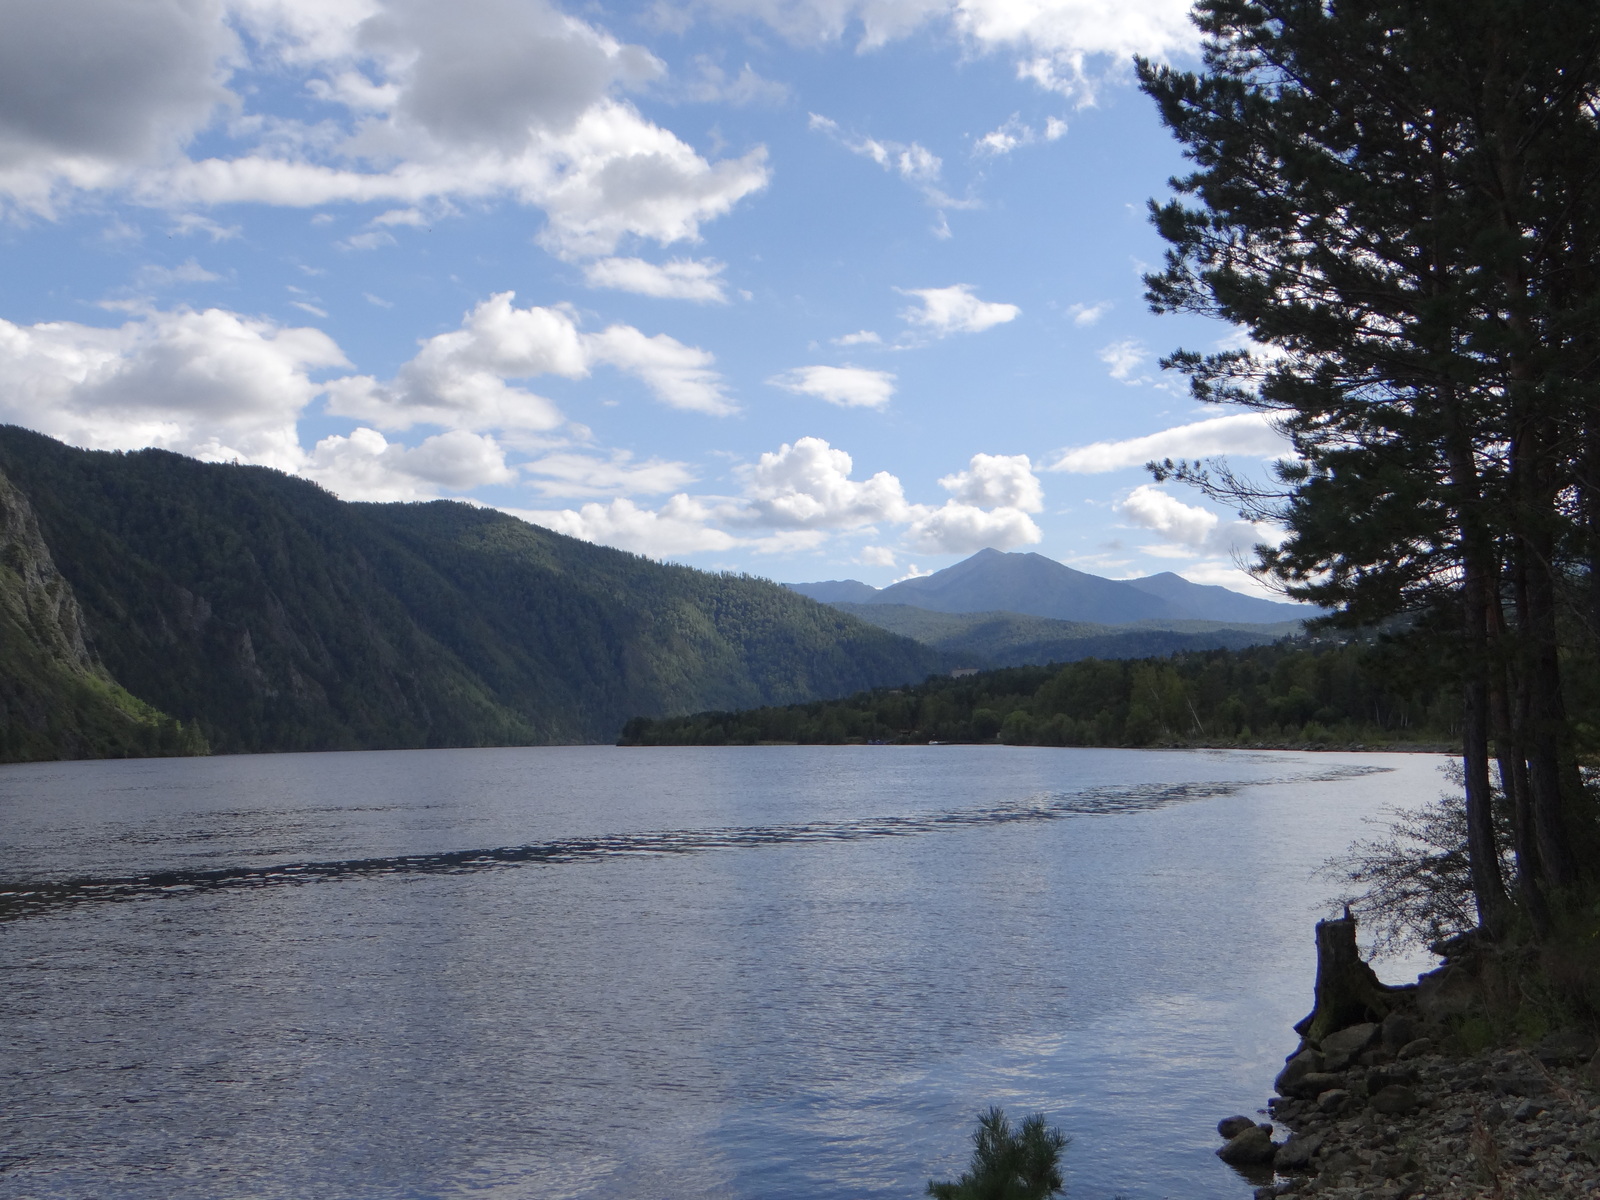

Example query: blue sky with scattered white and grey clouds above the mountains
[0,0,1285,594]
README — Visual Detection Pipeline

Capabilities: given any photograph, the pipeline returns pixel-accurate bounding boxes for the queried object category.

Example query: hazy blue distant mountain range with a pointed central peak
[787,550,1320,626]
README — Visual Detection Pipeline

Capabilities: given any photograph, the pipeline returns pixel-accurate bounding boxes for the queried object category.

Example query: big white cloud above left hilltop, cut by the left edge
[0,309,349,470]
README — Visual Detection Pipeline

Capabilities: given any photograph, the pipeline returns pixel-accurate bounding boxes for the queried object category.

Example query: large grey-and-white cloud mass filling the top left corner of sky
[0,0,768,258]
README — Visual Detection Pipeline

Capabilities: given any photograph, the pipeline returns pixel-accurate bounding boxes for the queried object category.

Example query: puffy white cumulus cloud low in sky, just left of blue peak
[726,437,912,530]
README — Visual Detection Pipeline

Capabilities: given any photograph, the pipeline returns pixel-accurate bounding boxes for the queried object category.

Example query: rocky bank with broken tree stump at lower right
[1218,920,1600,1200]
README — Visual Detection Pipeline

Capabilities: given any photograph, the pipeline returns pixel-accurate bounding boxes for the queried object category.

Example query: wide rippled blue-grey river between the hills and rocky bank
[0,747,1445,1200]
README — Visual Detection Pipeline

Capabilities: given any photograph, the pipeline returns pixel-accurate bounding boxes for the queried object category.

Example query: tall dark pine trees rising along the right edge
[1138,0,1600,936]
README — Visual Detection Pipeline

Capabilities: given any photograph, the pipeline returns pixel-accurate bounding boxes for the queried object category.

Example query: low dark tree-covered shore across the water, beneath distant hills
[621,640,1461,749]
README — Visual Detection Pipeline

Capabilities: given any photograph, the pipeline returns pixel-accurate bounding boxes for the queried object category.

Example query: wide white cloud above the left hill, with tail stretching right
[328,291,733,430]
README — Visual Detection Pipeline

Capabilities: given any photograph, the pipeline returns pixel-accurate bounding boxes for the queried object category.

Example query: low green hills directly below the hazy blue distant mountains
[834,600,1301,667]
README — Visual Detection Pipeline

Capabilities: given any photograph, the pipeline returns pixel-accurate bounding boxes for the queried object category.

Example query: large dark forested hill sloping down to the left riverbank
[0,426,944,757]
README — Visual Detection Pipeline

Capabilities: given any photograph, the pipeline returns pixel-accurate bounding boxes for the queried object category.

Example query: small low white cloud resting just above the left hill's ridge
[301,427,517,501]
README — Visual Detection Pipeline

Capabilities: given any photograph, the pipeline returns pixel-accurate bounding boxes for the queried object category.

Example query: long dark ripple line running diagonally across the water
[0,763,1392,922]
